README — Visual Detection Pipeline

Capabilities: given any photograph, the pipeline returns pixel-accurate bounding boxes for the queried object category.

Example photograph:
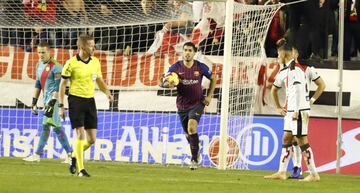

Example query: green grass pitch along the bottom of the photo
[0,157,360,193]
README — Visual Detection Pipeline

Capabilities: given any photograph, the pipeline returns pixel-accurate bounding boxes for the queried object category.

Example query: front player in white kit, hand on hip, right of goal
[264,44,320,181]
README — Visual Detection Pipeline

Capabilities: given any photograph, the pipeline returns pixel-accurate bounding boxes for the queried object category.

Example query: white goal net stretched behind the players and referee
[0,0,281,169]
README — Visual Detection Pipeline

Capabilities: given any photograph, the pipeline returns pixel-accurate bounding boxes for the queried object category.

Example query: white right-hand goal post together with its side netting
[218,0,282,169]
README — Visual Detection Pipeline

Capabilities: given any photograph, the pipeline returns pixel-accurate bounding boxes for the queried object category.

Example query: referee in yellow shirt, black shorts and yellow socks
[59,35,113,177]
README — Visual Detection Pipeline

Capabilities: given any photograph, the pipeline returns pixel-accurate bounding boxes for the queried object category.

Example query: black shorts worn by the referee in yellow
[68,95,97,129]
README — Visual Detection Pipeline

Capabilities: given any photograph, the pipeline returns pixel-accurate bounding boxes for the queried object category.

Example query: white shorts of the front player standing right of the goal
[284,110,310,136]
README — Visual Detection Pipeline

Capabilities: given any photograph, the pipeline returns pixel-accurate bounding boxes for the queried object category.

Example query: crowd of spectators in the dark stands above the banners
[0,0,360,61]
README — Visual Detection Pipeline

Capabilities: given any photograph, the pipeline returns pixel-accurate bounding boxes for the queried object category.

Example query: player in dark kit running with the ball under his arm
[159,42,216,170]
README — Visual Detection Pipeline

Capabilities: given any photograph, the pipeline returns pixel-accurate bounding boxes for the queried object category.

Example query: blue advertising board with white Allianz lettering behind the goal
[0,108,283,170]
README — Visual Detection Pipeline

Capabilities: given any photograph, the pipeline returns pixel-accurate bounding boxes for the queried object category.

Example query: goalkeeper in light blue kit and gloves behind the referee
[24,42,72,162]
